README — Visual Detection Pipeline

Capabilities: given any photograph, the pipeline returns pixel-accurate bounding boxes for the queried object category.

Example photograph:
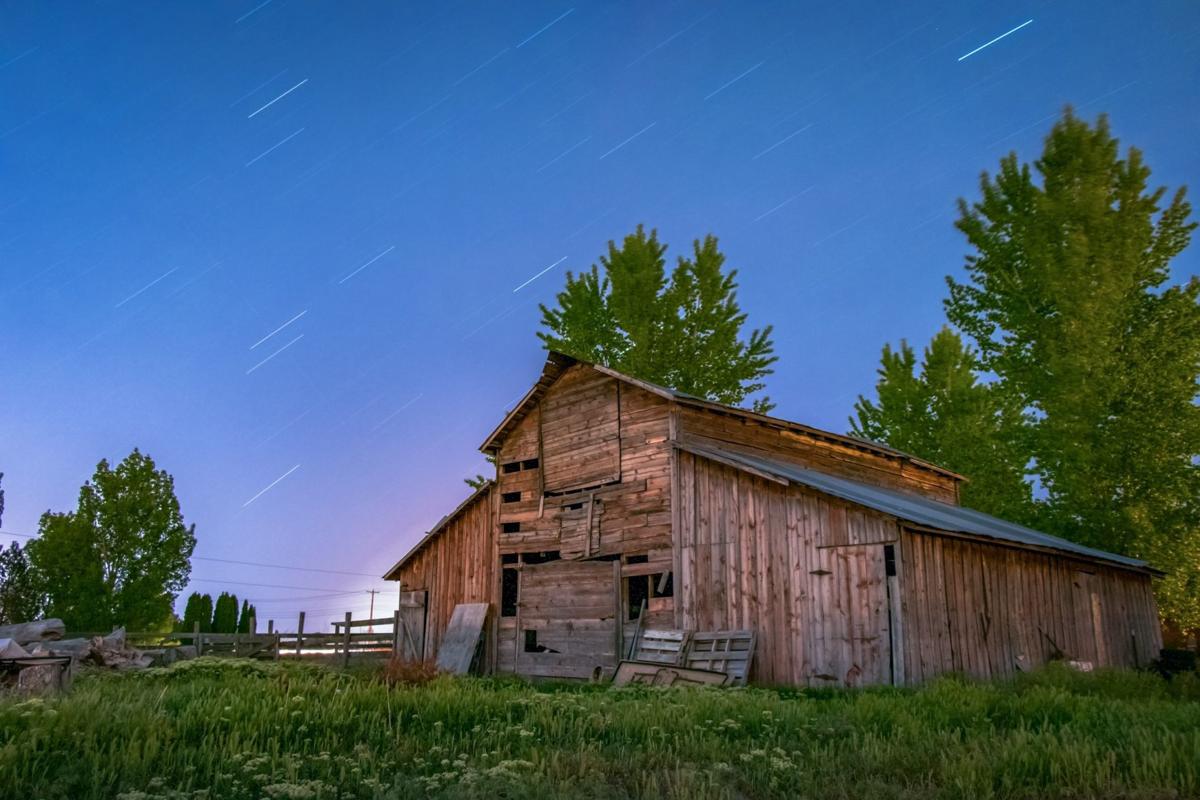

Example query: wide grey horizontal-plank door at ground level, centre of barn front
[515,561,620,678]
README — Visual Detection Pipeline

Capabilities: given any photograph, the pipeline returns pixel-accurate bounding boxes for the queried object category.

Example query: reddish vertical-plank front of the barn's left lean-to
[386,488,499,660]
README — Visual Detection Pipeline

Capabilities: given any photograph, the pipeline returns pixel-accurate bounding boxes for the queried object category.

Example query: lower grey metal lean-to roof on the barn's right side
[677,444,1151,570]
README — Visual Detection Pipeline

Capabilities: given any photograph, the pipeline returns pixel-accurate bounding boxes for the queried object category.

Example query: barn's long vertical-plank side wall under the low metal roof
[898,529,1163,682]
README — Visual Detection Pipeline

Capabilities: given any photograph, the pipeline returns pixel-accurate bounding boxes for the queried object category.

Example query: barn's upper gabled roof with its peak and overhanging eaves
[479,350,966,480]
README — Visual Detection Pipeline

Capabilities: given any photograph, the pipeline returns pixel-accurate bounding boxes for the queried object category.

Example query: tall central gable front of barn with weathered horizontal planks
[487,366,674,674]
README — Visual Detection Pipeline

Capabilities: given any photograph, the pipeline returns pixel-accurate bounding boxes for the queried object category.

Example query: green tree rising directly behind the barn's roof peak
[538,225,775,413]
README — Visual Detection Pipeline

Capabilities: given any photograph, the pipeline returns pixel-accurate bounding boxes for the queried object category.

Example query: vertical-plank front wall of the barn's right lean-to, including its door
[676,452,899,686]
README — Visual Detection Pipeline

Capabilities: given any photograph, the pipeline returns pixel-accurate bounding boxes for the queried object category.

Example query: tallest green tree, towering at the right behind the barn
[946,109,1200,627]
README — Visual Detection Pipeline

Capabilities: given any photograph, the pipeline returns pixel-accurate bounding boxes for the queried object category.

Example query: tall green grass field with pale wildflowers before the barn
[0,658,1200,800]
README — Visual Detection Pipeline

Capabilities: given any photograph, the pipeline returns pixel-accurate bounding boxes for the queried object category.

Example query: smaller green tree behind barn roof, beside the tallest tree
[851,327,1033,522]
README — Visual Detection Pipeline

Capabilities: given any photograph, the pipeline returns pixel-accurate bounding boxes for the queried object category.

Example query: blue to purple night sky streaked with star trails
[0,0,1200,630]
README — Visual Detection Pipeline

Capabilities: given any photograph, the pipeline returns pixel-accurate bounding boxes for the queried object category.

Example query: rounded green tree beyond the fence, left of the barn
[28,450,196,631]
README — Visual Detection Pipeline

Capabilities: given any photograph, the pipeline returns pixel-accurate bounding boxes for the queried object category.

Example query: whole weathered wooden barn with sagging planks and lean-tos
[385,353,1162,686]
